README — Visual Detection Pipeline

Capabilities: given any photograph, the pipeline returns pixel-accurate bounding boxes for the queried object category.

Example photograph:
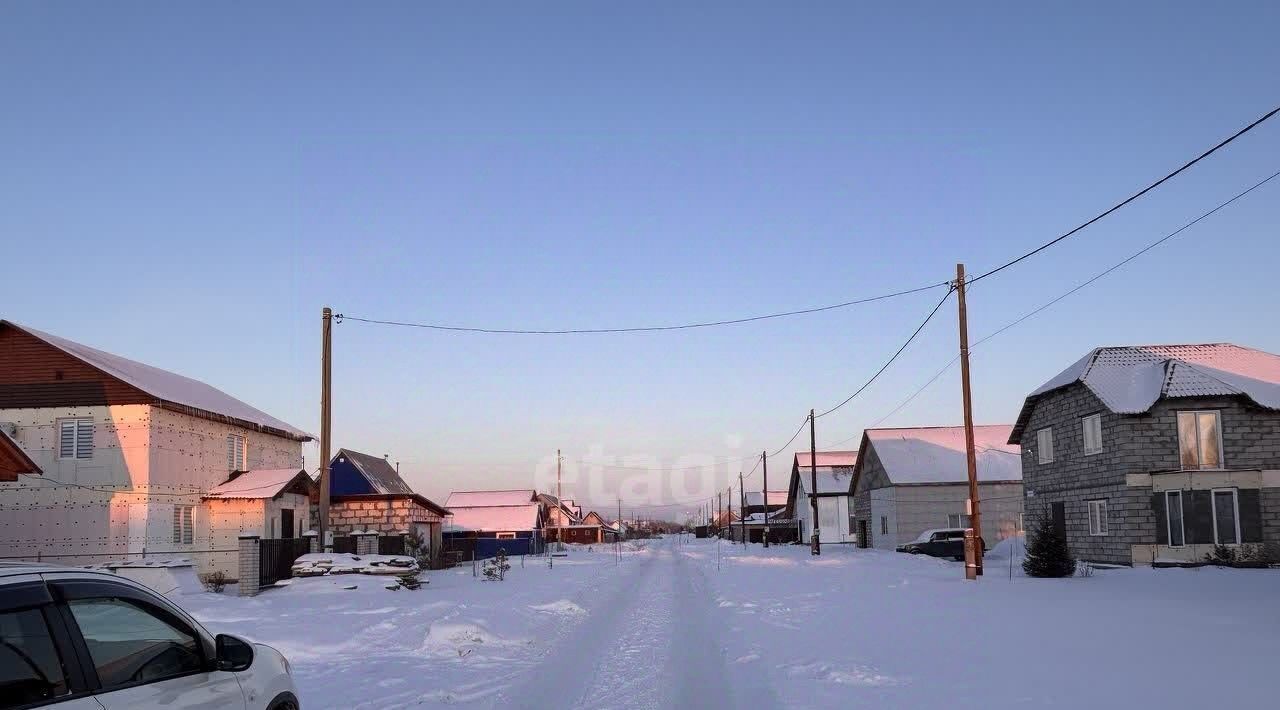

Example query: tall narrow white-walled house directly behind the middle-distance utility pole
[783,452,858,545]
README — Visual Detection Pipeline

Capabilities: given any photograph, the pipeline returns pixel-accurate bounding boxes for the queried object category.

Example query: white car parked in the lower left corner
[0,563,300,710]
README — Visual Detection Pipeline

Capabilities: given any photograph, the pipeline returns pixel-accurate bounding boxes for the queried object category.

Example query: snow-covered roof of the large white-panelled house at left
[0,320,314,441]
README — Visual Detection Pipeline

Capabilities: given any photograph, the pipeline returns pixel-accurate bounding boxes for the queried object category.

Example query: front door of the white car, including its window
[54,582,244,710]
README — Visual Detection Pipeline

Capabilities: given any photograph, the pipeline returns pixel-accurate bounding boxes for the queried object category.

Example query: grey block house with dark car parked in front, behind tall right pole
[854,425,1023,550]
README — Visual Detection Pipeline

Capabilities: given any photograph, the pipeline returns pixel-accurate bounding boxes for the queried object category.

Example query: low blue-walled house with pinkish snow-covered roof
[443,489,544,559]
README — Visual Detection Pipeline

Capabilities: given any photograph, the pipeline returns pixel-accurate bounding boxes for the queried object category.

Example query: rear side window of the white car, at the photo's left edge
[0,609,67,707]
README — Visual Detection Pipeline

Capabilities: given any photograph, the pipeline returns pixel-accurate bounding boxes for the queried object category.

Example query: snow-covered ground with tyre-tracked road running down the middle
[182,537,1280,709]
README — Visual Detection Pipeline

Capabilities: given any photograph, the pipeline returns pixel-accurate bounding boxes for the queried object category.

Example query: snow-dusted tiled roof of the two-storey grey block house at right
[1009,343,1280,444]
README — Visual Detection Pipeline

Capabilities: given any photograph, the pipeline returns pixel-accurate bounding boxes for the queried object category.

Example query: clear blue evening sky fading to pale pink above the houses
[0,3,1280,509]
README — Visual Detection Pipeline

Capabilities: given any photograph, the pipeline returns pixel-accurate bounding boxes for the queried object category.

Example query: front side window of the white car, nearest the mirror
[69,599,204,691]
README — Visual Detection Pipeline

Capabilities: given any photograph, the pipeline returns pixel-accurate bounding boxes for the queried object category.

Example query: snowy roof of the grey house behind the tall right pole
[864,423,1023,485]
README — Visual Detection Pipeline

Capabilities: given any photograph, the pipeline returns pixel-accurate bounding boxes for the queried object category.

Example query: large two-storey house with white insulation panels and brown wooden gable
[0,320,311,571]
